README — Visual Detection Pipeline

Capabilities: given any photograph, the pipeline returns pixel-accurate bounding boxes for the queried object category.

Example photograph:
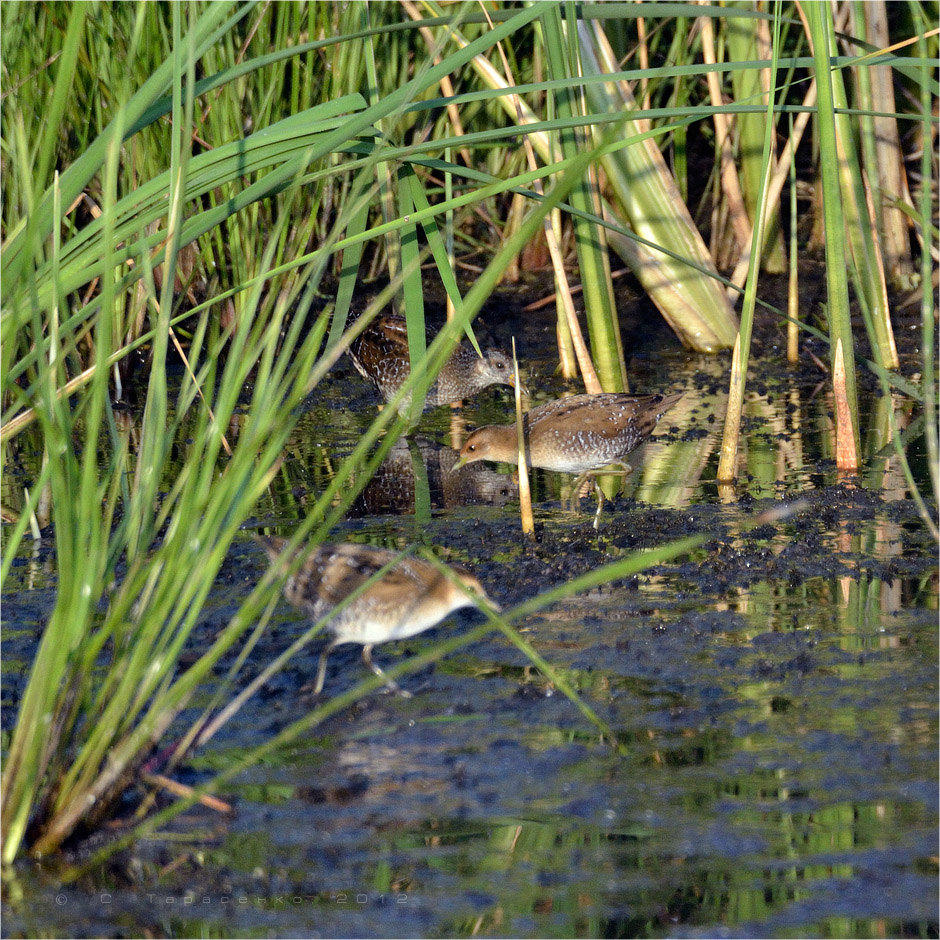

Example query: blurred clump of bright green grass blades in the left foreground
[3,1,620,861]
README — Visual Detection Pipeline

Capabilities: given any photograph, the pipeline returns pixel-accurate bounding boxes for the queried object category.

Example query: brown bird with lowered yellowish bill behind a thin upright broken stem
[456,392,682,528]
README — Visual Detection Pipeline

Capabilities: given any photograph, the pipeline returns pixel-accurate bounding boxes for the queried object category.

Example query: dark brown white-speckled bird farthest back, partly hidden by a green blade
[349,314,514,410]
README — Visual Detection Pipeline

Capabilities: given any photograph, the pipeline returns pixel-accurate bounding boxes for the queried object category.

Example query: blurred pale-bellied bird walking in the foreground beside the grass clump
[257,536,499,697]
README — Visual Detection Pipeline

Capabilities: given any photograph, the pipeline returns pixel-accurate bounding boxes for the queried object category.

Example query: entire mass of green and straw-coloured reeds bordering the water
[0,0,940,863]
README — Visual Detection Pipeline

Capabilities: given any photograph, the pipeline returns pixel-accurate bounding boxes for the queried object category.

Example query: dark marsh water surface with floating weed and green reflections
[3,320,938,937]
